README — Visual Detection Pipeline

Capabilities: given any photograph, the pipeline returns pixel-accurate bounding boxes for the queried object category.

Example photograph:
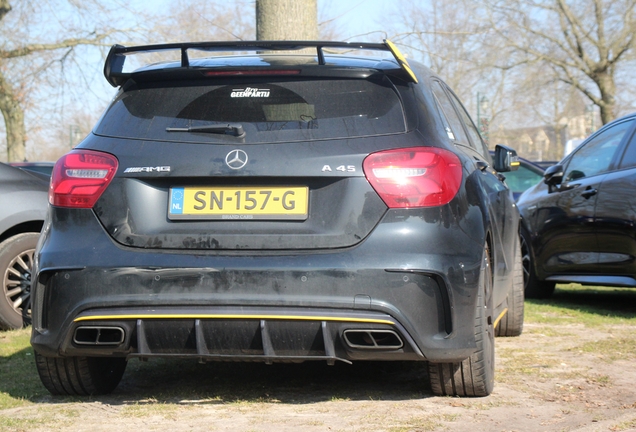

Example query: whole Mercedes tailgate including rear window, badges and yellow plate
[89,75,414,250]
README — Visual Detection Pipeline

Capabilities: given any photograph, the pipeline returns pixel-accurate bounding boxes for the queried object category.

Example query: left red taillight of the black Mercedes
[49,150,119,208]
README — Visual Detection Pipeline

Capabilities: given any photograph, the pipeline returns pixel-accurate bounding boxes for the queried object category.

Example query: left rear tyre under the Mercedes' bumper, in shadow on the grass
[35,352,127,396]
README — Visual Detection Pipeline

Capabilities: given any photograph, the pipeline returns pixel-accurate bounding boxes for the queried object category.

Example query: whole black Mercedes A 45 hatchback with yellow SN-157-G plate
[31,42,523,396]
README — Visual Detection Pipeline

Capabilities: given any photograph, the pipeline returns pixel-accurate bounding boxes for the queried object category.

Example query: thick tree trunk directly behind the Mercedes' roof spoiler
[256,0,318,40]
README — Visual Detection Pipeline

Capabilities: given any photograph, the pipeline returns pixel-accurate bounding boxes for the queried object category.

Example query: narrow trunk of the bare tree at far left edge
[0,73,26,162]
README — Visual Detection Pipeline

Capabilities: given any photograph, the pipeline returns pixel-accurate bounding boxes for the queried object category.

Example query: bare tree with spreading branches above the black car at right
[485,0,636,123]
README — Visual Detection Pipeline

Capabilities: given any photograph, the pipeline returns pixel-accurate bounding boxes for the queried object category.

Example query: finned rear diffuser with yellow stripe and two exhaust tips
[33,307,423,364]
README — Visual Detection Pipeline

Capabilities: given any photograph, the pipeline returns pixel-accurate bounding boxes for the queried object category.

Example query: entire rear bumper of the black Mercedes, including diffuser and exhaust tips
[31,209,483,362]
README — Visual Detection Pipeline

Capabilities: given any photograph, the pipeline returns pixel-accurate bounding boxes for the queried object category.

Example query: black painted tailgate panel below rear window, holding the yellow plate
[94,134,420,250]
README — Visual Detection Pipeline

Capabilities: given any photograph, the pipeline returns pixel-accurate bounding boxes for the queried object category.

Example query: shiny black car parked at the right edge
[518,114,636,297]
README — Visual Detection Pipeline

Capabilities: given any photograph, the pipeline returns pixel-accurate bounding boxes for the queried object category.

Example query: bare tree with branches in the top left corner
[0,0,148,161]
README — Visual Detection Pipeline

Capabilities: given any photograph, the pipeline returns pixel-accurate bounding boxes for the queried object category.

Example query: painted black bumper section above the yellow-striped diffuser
[33,199,486,360]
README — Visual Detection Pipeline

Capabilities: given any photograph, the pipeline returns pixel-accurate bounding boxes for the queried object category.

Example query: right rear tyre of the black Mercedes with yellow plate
[428,248,495,396]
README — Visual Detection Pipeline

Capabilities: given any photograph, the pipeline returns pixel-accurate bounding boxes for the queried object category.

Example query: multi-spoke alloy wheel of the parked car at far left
[0,233,40,329]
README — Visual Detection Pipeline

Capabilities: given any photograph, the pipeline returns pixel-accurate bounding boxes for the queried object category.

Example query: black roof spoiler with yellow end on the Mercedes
[104,39,417,87]
